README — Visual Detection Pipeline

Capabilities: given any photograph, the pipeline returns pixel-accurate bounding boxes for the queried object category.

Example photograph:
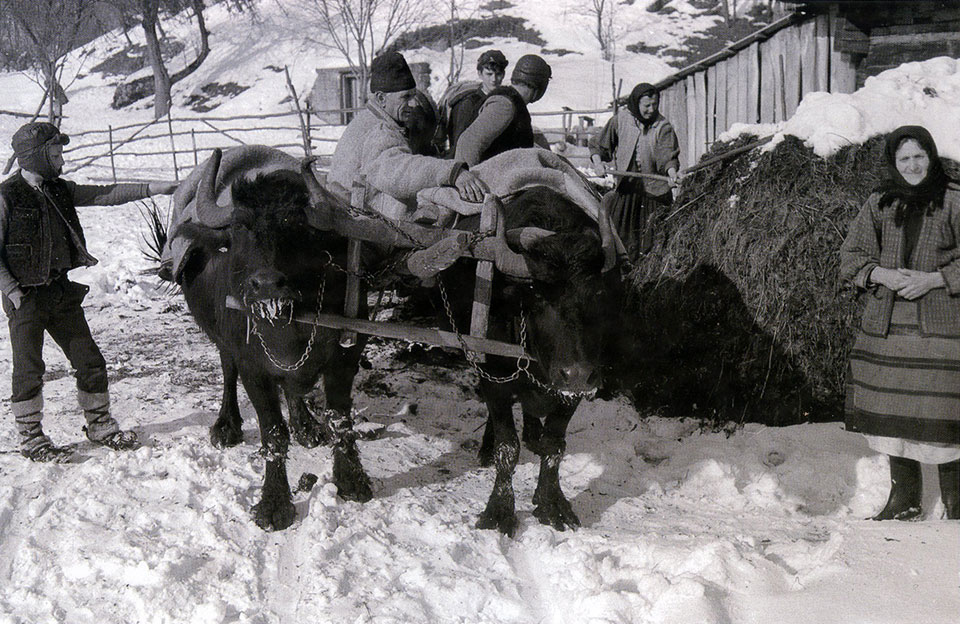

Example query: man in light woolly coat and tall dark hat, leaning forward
[327,52,488,219]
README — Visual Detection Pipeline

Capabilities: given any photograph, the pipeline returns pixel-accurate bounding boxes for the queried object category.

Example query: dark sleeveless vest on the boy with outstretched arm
[0,173,97,287]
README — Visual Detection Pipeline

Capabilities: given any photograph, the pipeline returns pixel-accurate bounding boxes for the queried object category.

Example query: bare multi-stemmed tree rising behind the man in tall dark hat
[300,0,429,100]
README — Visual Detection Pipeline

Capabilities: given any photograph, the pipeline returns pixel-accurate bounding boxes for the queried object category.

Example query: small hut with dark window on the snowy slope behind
[307,63,430,126]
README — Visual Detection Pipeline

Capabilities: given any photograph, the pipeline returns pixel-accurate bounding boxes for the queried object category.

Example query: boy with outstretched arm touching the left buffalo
[0,122,176,461]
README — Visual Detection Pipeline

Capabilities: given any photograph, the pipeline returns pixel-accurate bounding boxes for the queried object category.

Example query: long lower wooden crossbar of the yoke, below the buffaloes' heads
[227,297,536,361]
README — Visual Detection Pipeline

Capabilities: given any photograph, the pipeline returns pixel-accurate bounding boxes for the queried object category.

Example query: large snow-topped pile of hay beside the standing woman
[617,137,900,425]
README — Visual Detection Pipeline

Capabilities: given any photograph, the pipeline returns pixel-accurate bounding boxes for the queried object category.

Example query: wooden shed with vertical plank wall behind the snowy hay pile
[657,0,960,167]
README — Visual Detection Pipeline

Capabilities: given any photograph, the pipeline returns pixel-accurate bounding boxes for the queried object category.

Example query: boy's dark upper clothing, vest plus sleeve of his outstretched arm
[0,172,149,295]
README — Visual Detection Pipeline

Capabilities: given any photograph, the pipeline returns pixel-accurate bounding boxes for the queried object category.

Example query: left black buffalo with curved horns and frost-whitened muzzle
[171,148,372,530]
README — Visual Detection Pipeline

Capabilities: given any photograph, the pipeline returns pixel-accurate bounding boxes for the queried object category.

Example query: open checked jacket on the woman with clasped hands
[840,185,960,338]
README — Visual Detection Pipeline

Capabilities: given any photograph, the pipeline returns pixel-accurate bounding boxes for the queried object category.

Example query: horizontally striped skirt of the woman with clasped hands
[846,299,960,444]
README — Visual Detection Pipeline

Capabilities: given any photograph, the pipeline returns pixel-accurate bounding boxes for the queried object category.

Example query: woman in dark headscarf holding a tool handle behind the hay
[590,82,680,259]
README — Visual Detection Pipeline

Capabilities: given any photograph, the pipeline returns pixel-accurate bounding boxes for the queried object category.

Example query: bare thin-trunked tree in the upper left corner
[0,0,96,123]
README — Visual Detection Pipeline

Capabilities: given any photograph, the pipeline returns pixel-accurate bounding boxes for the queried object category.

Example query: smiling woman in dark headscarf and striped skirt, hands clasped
[840,126,960,520]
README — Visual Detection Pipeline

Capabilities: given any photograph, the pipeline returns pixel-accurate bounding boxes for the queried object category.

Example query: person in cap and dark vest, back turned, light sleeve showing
[454,54,552,165]
